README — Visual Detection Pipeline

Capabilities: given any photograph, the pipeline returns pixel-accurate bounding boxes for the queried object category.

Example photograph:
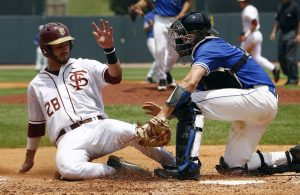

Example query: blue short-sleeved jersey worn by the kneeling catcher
[192,37,275,90]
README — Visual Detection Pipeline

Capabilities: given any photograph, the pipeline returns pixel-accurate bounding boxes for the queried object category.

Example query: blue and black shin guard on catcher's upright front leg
[173,102,203,180]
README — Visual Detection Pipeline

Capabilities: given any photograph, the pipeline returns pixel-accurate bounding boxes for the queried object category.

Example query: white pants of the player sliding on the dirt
[56,119,176,180]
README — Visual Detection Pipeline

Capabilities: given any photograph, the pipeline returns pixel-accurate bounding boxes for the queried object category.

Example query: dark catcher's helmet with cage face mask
[169,12,219,57]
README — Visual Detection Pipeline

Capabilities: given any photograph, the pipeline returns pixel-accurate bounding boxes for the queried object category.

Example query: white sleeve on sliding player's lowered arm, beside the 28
[27,85,46,124]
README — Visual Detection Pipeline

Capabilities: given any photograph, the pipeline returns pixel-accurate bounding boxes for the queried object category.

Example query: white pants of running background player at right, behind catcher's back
[241,30,275,71]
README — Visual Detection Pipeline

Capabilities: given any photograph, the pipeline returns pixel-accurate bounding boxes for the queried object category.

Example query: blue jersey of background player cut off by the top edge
[153,0,185,17]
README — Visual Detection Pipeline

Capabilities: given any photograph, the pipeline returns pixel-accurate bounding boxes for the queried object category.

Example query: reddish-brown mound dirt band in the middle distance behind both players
[0,81,300,105]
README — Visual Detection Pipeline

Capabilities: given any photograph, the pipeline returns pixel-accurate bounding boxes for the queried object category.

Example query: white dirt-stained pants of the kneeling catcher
[191,86,278,167]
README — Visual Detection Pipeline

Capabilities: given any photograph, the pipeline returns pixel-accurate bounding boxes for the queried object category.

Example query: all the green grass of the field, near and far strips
[0,65,300,147]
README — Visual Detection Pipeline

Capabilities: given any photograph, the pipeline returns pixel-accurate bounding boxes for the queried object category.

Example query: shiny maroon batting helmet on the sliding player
[39,22,74,57]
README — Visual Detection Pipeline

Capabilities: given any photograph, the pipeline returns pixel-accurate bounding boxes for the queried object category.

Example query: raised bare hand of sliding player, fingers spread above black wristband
[92,19,114,48]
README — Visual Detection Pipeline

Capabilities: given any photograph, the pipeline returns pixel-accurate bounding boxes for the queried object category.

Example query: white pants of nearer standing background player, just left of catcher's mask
[153,15,178,80]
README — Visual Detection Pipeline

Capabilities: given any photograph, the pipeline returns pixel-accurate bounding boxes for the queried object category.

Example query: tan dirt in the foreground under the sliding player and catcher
[0,146,300,195]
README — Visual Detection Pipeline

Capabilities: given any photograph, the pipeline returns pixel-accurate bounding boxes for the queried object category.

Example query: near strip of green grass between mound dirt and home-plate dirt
[0,104,300,148]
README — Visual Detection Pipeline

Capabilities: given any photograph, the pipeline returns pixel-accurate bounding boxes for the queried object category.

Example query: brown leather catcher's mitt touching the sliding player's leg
[136,117,171,147]
